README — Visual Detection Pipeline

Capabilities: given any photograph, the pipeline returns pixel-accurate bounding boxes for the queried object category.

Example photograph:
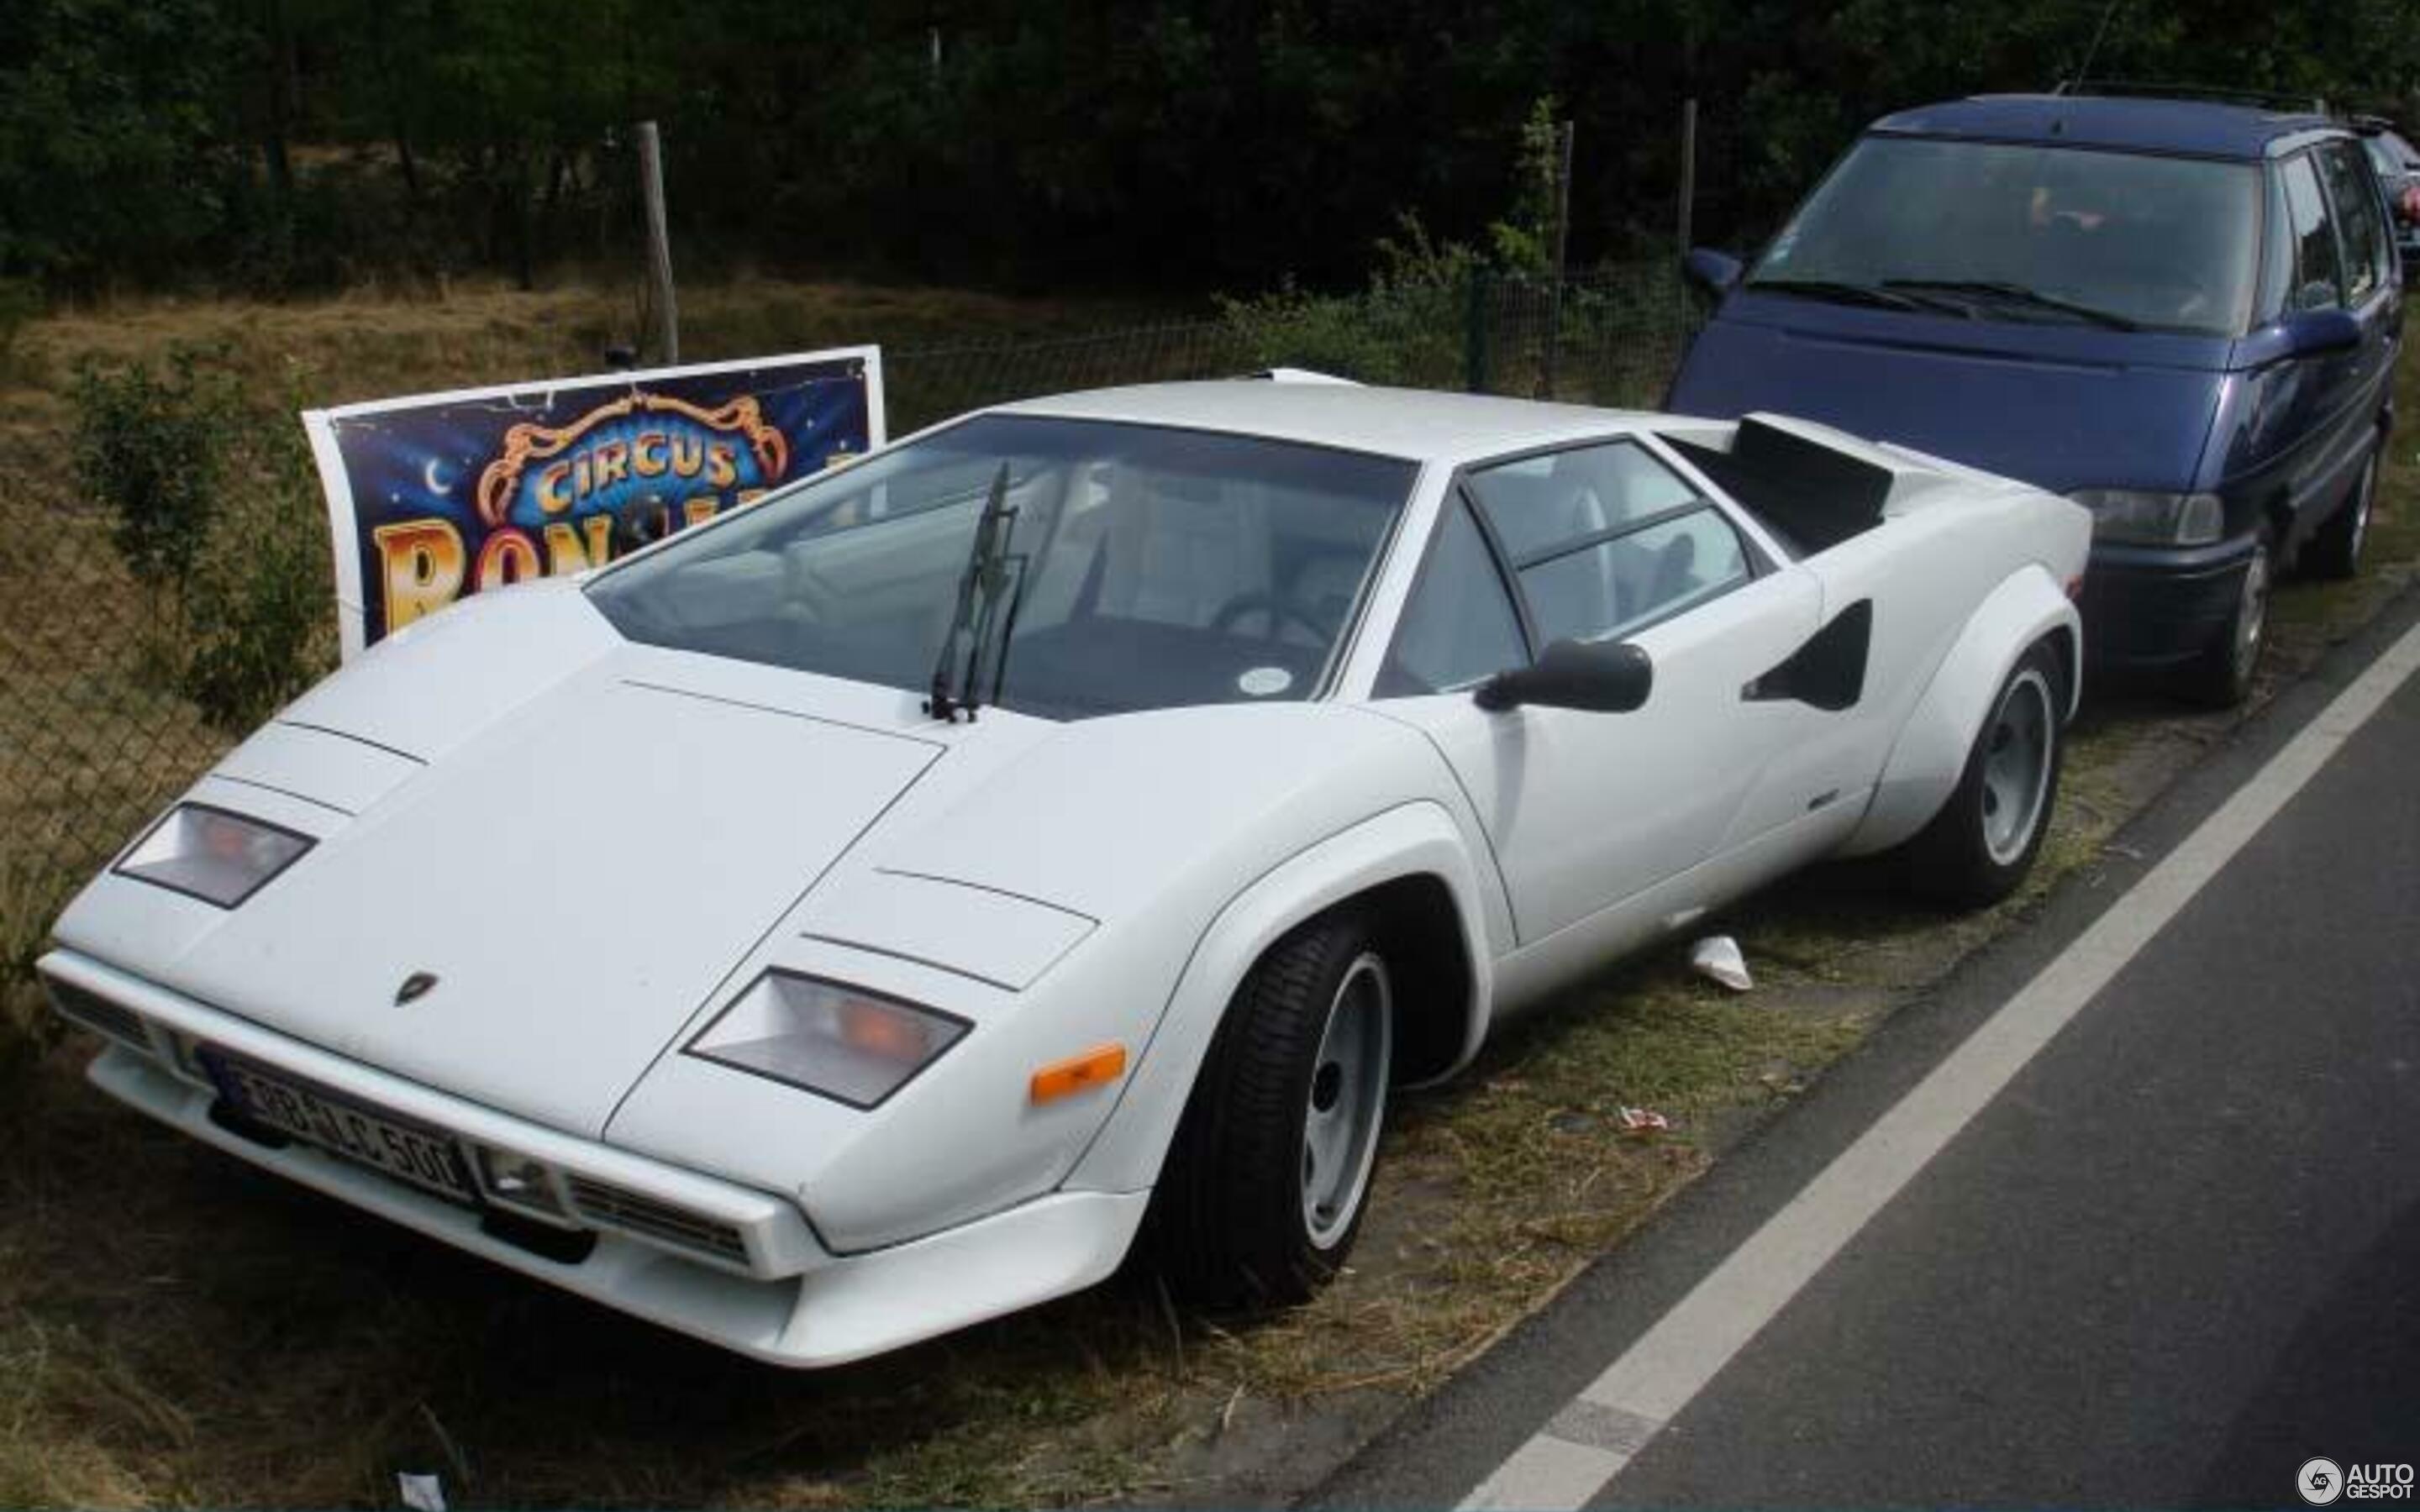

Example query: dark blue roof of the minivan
[1868,94,2343,160]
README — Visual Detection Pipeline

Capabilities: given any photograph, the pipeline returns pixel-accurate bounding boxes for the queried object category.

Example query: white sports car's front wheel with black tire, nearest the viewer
[1152,912,1394,1309]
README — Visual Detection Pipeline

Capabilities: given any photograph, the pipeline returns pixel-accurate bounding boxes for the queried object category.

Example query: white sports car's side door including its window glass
[1375,430,1820,943]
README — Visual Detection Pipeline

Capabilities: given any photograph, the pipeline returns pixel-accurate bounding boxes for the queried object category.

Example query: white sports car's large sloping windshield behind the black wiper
[588,416,1418,718]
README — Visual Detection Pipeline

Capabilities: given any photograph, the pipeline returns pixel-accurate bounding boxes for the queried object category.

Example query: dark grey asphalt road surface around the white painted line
[1312,592,2420,1507]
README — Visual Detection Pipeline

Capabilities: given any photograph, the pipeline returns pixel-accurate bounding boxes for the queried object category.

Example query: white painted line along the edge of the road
[1462,627,2420,1509]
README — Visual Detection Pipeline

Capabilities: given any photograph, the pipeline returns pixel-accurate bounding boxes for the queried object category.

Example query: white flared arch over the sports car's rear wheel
[1842,561,2084,857]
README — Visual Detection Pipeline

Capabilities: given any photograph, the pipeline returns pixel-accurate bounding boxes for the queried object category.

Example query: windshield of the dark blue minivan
[1749,135,2260,336]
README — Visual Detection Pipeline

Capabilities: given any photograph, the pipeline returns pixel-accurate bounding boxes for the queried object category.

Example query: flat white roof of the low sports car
[990,377,1653,462]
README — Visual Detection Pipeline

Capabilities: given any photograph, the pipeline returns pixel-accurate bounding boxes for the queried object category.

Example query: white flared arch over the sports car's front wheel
[1062,801,1491,1193]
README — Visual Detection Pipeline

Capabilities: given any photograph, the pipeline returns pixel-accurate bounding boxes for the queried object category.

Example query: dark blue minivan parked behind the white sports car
[1667,92,2403,704]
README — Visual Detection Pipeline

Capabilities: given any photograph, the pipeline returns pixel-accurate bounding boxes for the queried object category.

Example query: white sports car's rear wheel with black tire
[1902,641,2067,907]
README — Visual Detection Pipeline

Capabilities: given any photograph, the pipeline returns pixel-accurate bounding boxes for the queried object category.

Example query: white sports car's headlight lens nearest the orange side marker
[690,973,968,1108]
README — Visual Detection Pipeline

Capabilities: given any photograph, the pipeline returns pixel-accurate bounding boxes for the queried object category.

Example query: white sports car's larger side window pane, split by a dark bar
[1469,440,1752,646]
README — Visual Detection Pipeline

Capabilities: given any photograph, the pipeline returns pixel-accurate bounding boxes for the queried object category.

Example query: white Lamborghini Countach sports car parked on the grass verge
[41,377,2091,1367]
